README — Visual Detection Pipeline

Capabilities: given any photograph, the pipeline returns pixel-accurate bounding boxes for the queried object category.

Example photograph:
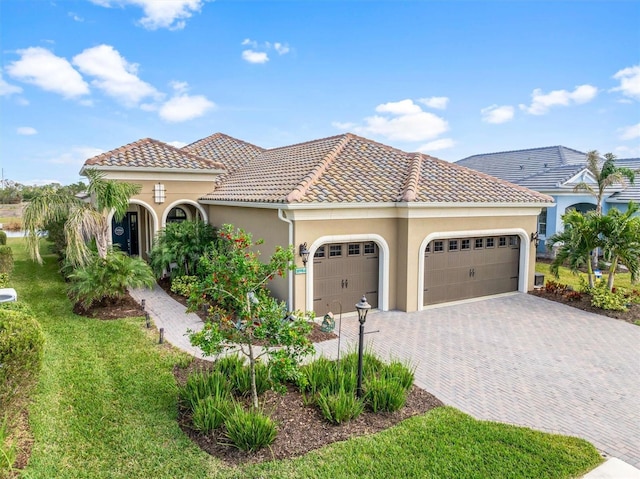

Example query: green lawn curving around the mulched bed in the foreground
[9,239,601,479]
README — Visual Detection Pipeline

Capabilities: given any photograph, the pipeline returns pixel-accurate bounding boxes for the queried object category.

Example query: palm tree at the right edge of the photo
[600,202,640,291]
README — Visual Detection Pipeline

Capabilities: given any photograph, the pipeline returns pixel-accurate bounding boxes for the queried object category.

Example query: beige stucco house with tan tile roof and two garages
[83,133,553,315]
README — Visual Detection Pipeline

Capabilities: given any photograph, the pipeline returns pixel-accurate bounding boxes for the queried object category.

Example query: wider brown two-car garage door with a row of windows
[424,236,520,306]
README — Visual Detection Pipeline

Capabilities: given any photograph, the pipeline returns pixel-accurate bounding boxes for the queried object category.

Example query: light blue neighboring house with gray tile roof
[456,146,640,255]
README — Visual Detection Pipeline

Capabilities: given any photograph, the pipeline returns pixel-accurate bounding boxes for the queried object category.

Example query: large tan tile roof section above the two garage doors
[202,133,552,203]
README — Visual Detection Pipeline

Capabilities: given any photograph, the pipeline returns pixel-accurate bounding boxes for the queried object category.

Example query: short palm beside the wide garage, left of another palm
[549,210,600,287]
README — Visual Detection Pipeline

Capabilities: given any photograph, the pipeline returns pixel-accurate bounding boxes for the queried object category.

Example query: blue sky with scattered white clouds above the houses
[0,0,640,184]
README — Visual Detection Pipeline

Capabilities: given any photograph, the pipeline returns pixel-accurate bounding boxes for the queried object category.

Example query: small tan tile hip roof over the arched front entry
[84,138,224,170]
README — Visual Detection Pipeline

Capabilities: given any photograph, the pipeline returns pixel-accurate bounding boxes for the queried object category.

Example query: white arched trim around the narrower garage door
[305,234,389,311]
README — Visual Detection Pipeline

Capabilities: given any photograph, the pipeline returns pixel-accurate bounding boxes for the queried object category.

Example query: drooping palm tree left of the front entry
[23,169,141,266]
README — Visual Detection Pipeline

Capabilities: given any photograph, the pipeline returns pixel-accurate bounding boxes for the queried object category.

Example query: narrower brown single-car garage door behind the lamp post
[313,241,379,317]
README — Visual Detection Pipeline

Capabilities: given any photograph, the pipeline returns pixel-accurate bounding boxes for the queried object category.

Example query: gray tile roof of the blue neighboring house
[456,146,587,189]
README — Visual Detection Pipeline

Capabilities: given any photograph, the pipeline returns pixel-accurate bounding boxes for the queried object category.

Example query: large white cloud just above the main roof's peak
[354,100,449,141]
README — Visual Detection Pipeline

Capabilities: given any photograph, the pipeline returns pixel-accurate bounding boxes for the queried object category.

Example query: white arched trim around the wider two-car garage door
[418,228,531,311]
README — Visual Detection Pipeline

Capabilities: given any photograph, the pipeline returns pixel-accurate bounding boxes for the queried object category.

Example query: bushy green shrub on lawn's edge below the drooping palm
[69,250,155,308]
